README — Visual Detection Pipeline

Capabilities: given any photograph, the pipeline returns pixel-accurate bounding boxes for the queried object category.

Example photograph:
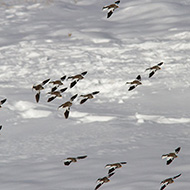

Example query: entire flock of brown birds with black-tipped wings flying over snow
[0,1,184,190]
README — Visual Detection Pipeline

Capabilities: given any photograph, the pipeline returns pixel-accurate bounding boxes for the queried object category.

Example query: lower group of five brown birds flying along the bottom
[60,147,181,190]
